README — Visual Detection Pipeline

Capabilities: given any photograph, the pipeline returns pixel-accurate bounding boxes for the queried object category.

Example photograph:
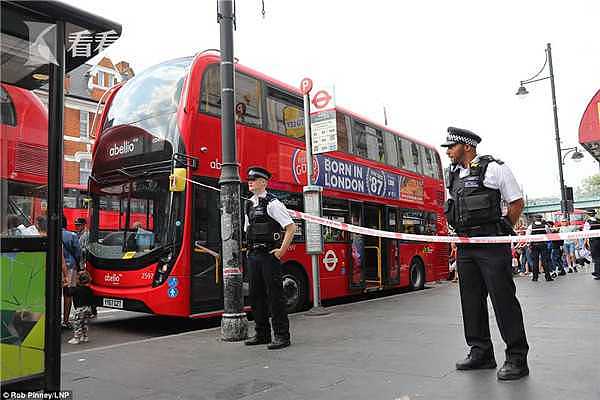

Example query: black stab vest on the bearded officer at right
[447,156,503,236]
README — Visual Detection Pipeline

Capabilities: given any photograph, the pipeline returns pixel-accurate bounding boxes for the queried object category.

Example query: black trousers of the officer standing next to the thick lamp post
[248,249,290,340]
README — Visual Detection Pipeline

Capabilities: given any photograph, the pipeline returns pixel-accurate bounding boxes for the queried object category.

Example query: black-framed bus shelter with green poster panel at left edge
[0,1,121,392]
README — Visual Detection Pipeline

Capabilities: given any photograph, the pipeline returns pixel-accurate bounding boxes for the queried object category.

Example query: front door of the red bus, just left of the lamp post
[189,178,223,314]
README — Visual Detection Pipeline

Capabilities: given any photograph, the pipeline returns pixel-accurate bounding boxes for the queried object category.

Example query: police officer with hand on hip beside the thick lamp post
[244,167,296,350]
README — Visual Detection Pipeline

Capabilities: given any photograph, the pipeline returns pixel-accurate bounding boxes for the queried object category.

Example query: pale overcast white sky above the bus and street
[69,0,600,198]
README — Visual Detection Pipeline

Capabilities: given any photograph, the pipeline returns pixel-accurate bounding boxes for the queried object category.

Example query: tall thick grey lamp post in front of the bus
[217,0,248,342]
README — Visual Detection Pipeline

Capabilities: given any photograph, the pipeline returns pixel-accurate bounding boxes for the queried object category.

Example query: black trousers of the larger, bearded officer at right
[457,243,529,360]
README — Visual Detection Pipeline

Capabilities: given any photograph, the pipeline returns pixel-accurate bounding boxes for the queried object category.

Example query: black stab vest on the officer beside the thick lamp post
[246,193,282,248]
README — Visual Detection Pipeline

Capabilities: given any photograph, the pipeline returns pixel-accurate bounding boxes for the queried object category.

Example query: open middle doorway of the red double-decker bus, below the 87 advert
[363,204,383,288]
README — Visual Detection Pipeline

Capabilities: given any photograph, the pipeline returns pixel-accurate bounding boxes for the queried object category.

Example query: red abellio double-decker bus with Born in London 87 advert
[88,52,448,317]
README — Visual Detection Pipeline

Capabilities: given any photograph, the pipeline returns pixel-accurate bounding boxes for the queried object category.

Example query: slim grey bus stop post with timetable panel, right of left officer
[301,91,328,315]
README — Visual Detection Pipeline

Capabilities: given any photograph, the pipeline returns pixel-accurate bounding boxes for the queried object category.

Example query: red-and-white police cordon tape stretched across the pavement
[288,210,600,244]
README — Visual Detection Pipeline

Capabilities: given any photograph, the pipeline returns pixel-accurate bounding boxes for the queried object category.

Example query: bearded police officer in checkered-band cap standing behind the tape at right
[442,127,529,380]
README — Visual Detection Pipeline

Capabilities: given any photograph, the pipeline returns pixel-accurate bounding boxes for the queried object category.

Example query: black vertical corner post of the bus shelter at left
[44,21,65,392]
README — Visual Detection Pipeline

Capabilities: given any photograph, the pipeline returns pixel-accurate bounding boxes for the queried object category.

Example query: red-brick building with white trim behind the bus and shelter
[35,57,134,185]
